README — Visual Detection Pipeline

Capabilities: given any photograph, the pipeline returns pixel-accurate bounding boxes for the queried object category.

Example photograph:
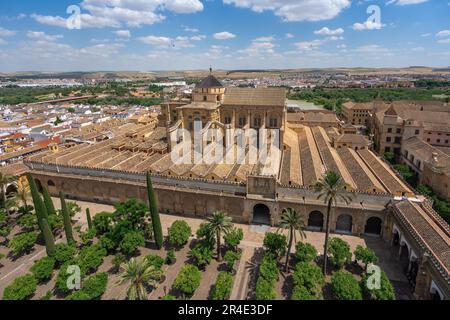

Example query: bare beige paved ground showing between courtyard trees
[0,198,411,299]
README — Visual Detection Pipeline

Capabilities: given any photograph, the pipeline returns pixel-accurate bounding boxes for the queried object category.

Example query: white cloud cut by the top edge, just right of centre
[223,0,351,21]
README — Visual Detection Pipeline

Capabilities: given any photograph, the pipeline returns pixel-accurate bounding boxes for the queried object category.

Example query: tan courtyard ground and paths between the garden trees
[0,198,412,300]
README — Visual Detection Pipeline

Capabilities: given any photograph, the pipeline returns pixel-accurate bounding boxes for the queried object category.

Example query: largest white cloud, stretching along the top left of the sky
[31,0,203,28]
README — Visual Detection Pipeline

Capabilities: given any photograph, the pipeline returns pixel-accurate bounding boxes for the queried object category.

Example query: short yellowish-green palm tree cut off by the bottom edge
[118,258,162,300]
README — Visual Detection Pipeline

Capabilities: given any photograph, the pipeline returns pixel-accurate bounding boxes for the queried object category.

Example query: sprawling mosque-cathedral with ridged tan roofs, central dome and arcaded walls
[24,75,450,299]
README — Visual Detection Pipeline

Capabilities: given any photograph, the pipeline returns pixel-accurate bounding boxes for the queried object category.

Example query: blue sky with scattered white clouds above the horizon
[0,0,450,72]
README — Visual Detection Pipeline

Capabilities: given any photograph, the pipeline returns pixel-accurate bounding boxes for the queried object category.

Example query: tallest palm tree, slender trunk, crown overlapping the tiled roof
[313,171,352,275]
